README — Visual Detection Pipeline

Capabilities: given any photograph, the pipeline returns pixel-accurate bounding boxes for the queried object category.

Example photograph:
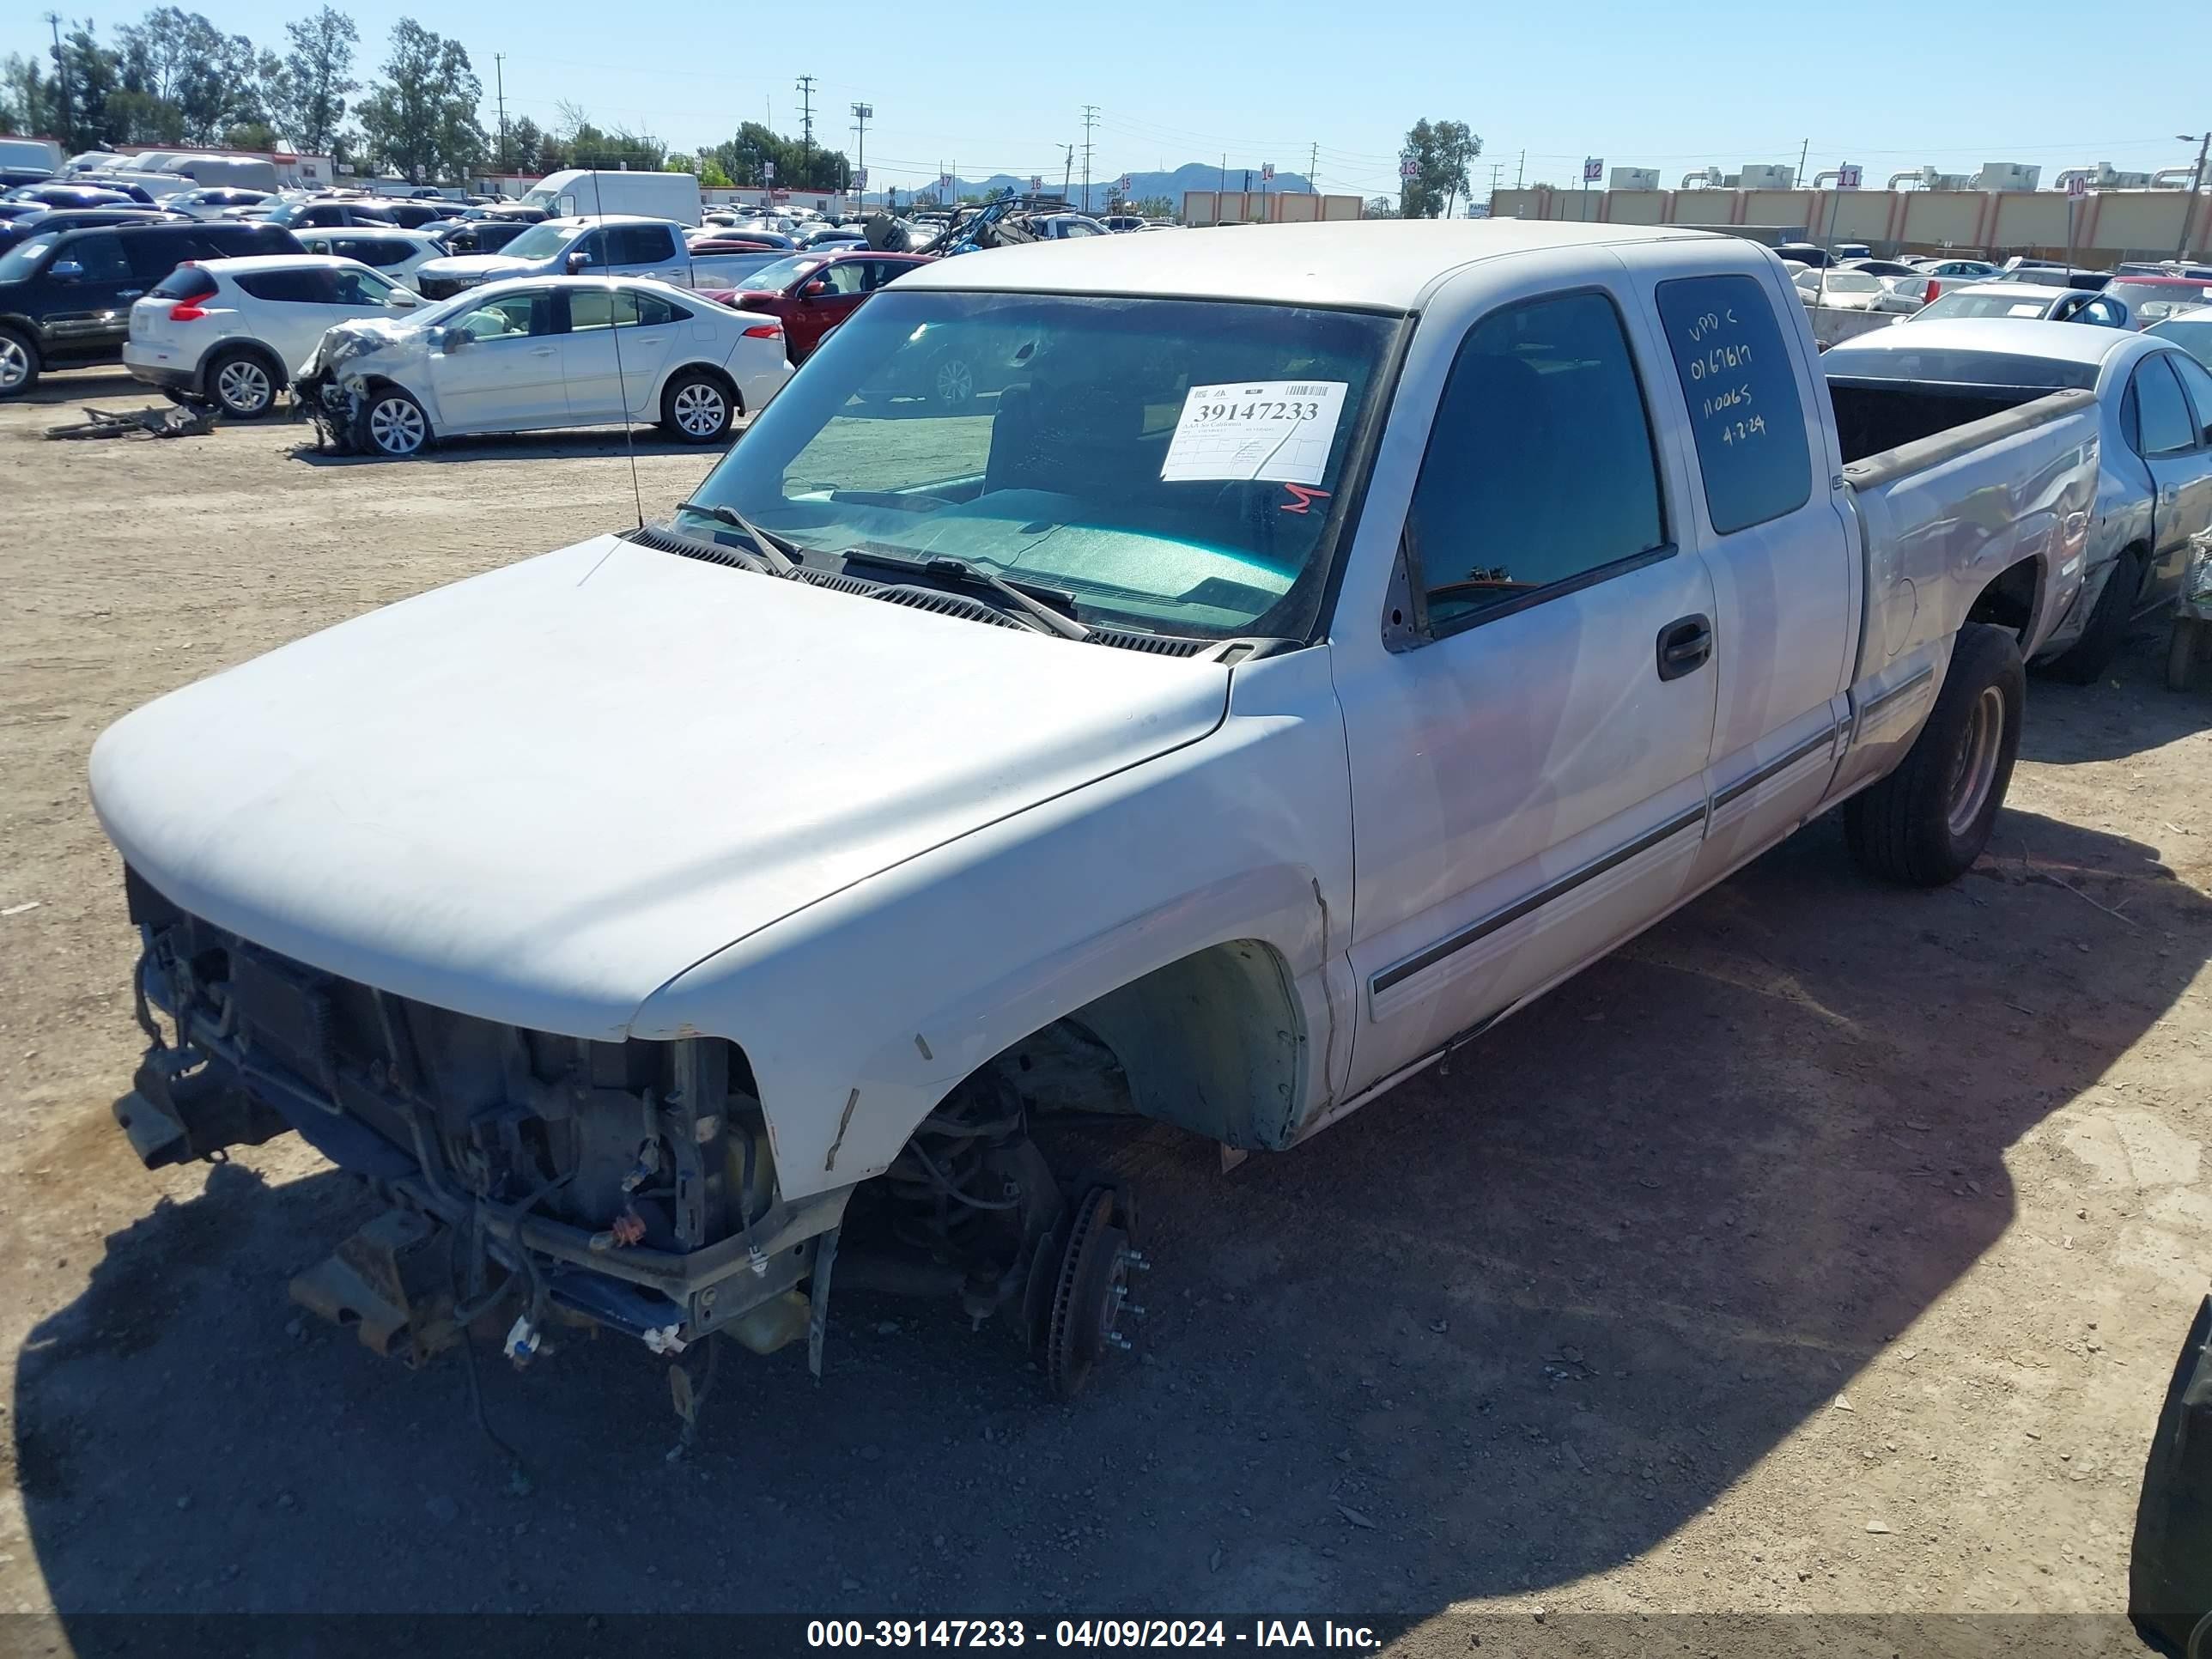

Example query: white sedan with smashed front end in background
[296,276,792,456]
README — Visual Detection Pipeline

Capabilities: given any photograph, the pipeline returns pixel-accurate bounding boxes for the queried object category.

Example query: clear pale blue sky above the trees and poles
[0,0,2212,195]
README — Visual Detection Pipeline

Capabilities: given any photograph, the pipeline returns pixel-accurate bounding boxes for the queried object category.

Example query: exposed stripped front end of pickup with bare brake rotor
[115,872,1144,1394]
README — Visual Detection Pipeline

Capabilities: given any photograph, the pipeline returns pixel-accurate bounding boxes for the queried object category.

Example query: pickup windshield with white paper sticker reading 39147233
[679,288,1401,639]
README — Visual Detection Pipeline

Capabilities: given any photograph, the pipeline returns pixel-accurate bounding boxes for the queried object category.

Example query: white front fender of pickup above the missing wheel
[630,644,1352,1199]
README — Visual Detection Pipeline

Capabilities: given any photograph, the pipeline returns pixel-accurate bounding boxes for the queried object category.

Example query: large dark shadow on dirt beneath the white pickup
[11,814,2212,1628]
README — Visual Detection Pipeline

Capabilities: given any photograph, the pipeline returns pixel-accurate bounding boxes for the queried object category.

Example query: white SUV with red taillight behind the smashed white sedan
[124,254,422,420]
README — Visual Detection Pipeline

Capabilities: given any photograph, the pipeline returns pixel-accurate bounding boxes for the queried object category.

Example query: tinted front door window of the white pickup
[1405,295,1666,629]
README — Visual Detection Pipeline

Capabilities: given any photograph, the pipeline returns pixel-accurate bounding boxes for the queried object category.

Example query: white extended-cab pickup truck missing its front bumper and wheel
[91,222,2097,1389]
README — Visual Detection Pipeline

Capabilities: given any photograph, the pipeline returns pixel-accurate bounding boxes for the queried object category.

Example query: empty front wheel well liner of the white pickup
[959,940,1310,1148]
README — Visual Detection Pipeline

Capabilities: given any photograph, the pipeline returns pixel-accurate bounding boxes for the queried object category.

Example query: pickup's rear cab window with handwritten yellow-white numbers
[1659,276,1812,535]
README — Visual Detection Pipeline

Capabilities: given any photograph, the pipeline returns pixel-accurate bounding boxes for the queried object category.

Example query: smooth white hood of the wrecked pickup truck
[91,535,1230,1040]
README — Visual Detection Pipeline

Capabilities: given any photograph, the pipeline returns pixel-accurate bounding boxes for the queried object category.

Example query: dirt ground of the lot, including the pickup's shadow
[0,362,2212,1652]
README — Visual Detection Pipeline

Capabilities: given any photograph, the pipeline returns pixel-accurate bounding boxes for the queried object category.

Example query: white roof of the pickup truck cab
[898,219,1721,312]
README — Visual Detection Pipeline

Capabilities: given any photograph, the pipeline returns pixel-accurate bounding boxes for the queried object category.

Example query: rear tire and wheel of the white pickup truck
[1843,622,2027,887]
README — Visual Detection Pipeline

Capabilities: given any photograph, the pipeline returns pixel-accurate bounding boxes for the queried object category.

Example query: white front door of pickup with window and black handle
[1332,263,1719,1088]
